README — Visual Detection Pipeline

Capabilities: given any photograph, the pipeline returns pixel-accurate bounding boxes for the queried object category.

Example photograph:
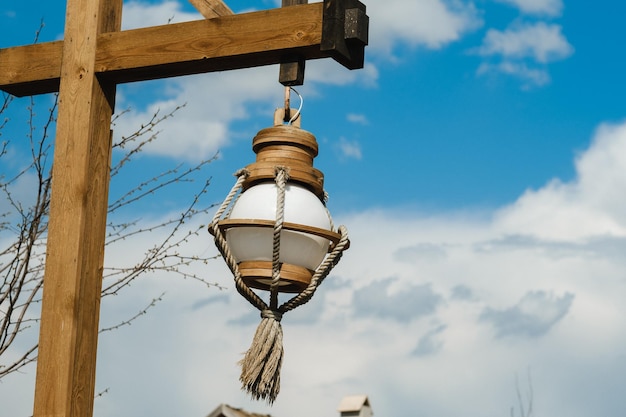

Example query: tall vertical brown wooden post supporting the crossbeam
[33,0,122,417]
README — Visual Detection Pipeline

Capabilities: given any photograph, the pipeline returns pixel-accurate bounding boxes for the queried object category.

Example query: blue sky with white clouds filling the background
[0,0,626,417]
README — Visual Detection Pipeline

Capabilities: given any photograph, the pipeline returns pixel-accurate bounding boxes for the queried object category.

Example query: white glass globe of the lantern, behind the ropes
[226,182,331,270]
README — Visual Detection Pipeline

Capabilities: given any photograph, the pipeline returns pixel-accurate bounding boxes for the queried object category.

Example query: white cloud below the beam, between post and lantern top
[114,67,283,161]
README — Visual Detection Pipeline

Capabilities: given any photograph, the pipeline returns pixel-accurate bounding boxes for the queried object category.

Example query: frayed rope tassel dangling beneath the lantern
[239,310,284,404]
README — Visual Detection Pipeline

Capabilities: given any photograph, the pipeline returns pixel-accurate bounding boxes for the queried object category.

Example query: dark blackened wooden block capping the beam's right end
[320,0,369,69]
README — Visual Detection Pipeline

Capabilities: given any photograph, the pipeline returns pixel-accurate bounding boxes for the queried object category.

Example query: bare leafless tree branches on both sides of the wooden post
[0,88,221,381]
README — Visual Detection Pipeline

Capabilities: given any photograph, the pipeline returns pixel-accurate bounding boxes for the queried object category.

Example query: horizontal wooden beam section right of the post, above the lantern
[96,3,329,83]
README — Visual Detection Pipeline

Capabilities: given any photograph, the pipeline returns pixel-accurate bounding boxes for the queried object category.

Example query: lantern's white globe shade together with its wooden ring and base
[225,182,332,292]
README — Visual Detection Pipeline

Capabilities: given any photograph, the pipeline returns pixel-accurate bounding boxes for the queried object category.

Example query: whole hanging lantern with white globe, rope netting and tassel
[209,98,349,403]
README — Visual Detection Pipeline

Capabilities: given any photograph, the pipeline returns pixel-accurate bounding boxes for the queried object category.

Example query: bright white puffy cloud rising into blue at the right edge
[498,118,626,241]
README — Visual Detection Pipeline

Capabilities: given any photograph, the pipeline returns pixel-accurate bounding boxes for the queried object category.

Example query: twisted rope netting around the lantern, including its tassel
[209,167,349,404]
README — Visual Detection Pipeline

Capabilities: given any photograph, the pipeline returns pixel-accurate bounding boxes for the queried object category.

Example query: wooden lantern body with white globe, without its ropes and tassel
[212,109,341,293]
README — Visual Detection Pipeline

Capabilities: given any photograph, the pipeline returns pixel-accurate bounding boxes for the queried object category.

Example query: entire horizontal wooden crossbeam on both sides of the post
[0,3,345,96]
